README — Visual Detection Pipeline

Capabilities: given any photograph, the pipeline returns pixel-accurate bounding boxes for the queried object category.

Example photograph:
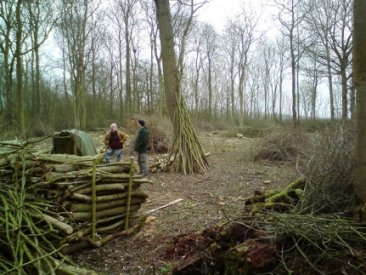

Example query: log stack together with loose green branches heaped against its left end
[0,142,152,273]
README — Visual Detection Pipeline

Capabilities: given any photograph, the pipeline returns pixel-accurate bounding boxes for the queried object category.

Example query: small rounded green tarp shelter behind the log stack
[52,129,97,156]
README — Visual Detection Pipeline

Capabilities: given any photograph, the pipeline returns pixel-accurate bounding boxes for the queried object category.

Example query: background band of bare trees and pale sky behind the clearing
[0,0,356,134]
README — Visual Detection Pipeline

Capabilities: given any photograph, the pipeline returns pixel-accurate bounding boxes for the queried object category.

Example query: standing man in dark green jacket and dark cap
[135,120,149,176]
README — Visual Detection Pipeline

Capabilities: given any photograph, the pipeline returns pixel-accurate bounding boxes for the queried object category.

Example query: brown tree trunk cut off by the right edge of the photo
[353,0,366,222]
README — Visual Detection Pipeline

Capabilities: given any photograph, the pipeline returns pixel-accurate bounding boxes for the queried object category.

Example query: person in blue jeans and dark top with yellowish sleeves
[104,123,127,163]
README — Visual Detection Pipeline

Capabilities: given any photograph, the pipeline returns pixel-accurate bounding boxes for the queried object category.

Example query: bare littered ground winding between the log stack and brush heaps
[73,134,296,274]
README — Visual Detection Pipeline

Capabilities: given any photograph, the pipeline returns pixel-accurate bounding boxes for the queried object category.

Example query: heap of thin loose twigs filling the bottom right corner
[257,211,366,274]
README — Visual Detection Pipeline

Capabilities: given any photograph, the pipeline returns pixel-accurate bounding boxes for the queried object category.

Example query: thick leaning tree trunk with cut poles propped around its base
[154,0,208,174]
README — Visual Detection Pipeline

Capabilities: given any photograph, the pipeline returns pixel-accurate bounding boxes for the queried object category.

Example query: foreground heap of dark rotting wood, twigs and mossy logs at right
[173,189,366,274]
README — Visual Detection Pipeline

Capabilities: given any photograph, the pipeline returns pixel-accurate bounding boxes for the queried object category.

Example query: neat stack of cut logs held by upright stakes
[0,147,152,254]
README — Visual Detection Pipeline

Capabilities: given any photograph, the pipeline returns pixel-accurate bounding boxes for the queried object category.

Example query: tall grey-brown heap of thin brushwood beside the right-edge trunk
[297,125,354,213]
